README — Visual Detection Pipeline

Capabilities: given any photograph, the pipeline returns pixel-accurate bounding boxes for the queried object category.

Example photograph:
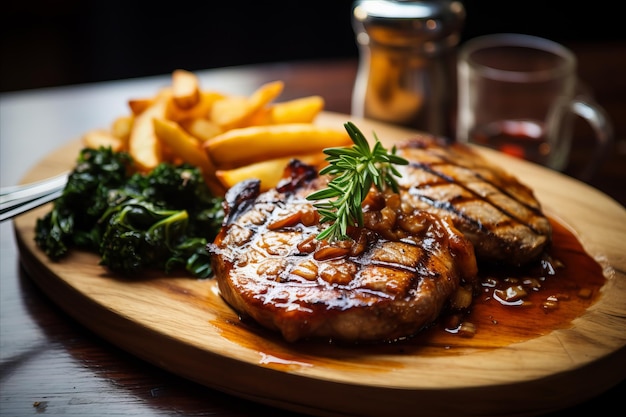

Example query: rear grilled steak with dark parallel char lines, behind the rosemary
[398,135,552,265]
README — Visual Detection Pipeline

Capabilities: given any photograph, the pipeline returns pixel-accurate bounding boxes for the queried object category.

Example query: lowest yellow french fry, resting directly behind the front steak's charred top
[215,153,323,192]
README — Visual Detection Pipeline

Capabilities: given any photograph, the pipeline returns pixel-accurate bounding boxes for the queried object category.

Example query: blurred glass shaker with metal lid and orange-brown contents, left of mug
[352,0,465,138]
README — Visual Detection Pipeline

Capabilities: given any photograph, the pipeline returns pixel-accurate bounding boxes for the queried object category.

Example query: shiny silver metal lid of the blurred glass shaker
[352,0,465,52]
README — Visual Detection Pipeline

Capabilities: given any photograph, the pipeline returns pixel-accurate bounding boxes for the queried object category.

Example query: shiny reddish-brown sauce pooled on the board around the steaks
[211,219,606,360]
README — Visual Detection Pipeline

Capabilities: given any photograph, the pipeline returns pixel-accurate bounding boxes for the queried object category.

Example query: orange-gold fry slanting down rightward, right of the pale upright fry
[152,118,224,195]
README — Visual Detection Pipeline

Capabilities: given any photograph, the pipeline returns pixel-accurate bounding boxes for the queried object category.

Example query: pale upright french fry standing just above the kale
[128,89,172,171]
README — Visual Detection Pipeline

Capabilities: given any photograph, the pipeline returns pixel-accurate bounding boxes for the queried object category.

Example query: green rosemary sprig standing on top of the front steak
[307,122,408,241]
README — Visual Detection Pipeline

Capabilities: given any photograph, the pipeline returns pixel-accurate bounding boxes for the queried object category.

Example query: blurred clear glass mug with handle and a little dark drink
[456,33,613,180]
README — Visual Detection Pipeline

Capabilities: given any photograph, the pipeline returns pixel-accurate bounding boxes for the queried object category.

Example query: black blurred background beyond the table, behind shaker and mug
[0,0,626,92]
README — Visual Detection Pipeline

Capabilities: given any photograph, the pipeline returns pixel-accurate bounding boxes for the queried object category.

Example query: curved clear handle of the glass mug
[569,95,613,182]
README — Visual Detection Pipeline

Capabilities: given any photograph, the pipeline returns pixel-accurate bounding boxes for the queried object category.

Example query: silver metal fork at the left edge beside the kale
[0,172,69,222]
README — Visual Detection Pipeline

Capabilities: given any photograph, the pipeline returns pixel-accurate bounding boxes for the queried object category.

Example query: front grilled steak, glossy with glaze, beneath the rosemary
[208,159,477,342]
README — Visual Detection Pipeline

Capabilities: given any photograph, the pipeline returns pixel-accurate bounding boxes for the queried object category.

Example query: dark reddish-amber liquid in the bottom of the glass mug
[470,120,550,164]
